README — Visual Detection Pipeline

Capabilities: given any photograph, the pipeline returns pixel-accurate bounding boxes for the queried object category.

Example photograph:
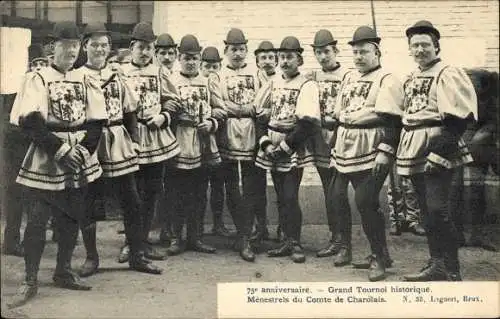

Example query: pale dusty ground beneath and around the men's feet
[1,221,500,318]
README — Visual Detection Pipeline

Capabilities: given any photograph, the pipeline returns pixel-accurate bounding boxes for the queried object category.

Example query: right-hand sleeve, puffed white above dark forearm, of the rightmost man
[428,67,478,162]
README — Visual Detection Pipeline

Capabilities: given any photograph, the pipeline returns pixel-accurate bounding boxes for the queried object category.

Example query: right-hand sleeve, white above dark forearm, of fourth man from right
[280,81,321,154]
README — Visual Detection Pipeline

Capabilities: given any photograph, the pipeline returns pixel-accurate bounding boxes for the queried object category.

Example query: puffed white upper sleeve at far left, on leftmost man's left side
[10,72,49,126]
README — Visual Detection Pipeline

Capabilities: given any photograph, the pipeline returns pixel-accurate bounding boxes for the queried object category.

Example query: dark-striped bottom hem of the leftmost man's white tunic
[16,164,102,191]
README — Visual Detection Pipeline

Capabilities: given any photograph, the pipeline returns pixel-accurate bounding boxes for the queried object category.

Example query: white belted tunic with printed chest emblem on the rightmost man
[396,61,477,176]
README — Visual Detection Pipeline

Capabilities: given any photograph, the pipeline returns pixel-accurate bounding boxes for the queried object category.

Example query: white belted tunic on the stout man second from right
[333,67,403,173]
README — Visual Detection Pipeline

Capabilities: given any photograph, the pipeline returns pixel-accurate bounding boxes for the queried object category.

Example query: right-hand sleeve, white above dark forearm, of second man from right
[375,74,404,155]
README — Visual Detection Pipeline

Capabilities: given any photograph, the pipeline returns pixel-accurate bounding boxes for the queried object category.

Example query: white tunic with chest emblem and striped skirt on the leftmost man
[11,67,107,191]
